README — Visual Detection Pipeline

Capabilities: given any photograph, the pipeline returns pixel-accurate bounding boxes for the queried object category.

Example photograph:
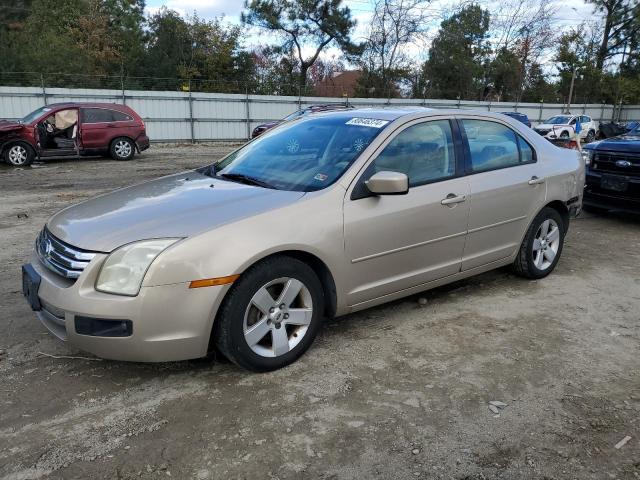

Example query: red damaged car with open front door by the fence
[0,103,149,167]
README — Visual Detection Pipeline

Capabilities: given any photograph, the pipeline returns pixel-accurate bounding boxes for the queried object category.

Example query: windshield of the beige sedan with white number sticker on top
[208,115,389,192]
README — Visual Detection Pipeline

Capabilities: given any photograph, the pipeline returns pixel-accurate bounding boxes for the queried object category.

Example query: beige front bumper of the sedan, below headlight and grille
[25,254,228,362]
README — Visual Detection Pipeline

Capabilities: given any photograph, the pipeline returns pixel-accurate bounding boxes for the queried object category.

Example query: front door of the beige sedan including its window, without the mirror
[344,119,470,306]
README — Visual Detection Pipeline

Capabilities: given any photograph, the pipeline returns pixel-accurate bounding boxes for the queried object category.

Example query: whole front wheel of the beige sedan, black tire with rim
[212,256,324,372]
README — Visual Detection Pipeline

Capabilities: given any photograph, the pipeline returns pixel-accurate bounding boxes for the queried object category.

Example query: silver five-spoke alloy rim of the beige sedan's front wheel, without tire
[243,277,313,357]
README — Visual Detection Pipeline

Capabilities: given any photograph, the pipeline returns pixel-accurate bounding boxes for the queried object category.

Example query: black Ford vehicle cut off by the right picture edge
[582,125,640,213]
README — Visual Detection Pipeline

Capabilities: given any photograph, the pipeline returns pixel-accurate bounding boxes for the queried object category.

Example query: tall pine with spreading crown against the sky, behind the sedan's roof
[241,0,359,89]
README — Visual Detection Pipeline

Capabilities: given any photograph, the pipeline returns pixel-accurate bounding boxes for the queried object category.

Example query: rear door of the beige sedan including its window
[459,118,546,271]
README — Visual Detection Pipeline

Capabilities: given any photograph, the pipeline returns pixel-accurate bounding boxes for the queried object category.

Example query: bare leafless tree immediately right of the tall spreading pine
[357,0,430,97]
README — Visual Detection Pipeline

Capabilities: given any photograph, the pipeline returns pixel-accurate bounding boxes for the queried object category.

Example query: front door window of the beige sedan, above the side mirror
[370,120,456,186]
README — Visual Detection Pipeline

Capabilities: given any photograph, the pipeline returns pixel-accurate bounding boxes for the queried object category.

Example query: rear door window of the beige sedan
[462,120,535,172]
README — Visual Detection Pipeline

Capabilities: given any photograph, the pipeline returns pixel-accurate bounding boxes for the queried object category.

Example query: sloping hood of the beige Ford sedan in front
[47,171,304,252]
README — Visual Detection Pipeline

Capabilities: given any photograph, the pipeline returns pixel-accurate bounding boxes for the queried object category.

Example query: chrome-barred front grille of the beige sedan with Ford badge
[36,227,96,279]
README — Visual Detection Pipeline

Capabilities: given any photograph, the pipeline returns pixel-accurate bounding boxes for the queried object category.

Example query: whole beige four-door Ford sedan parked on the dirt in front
[23,108,584,371]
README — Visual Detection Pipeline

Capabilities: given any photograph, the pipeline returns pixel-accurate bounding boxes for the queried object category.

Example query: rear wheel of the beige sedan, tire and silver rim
[513,207,566,279]
